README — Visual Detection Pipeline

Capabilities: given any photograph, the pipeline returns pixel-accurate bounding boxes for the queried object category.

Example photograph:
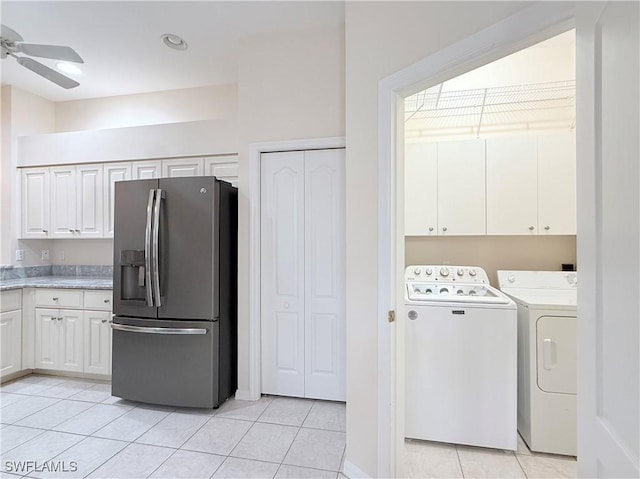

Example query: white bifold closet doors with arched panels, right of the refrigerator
[260,149,345,401]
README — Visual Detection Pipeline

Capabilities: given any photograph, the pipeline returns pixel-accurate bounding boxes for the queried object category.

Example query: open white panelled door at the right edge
[576,2,640,477]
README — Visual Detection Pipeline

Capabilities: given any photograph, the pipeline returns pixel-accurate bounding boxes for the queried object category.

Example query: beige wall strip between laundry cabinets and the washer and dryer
[405,236,576,287]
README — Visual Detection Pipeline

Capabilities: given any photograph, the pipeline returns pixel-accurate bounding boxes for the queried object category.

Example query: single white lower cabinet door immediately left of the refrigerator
[83,311,111,374]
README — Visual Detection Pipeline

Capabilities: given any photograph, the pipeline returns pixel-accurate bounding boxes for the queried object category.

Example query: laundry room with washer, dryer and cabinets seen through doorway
[400,30,577,477]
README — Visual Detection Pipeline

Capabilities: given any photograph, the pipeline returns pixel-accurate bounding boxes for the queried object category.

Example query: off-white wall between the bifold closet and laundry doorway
[345,2,527,477]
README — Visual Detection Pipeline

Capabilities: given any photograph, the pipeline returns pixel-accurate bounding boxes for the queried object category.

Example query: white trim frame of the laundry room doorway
[377,2,576,477]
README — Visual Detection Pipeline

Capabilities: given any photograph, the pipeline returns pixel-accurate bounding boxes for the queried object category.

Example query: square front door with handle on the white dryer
[536,316,576,394]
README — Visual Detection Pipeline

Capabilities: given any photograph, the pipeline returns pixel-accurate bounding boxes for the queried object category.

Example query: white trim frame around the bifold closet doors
[245,136,346,401]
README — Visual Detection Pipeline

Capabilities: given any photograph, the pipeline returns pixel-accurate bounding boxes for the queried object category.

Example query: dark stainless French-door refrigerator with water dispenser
[111,176,238,408]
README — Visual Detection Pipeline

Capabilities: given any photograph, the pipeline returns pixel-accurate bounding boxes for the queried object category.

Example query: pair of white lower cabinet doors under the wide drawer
[35,308,84,372]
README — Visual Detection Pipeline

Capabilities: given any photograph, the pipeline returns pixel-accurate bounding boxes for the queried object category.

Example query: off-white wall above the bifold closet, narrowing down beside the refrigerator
[238,23,345,398]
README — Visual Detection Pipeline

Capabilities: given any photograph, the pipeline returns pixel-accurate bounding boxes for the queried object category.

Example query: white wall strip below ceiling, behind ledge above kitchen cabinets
[55,85,238,132]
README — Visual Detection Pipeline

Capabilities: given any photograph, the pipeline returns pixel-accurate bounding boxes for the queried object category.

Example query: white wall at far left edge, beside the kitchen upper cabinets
[0,86,55,266]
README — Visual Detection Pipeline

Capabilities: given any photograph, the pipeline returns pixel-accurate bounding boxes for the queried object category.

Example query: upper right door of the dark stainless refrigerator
[158,177,220,320]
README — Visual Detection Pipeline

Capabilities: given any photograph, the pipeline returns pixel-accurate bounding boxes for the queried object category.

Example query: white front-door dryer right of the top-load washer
[498,271,578,456]
